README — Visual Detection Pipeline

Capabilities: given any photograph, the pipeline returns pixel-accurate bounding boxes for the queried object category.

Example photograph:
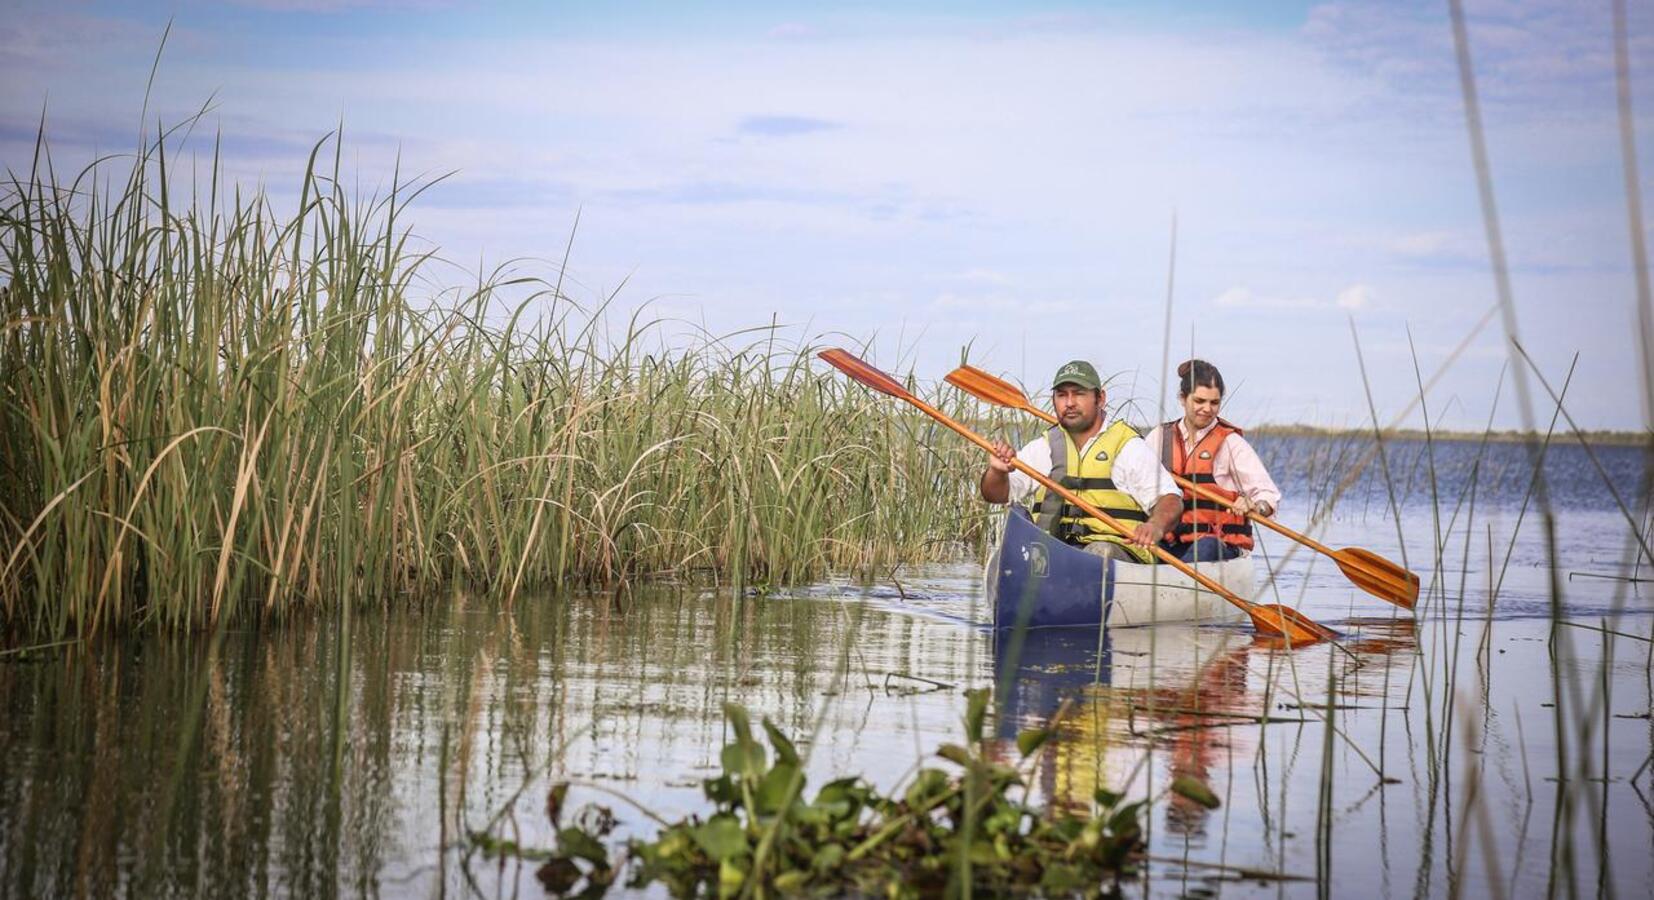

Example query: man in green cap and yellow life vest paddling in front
[981,359,1183,563]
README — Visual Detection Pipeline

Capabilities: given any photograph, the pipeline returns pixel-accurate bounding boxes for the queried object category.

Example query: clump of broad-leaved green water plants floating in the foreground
[471,690,1151,897]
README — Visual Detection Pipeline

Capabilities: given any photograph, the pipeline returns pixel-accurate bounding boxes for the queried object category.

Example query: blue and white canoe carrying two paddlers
[986,506,1252,629]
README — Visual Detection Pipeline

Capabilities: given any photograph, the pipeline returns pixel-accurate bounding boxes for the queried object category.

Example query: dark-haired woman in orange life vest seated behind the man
[1148,359,1280,563]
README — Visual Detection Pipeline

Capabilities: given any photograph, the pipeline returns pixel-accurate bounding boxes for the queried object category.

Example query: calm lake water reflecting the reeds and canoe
[0,438,1654,897]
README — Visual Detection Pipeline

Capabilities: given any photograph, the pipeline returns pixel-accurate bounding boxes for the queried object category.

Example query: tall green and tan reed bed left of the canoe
[0,136,987,637]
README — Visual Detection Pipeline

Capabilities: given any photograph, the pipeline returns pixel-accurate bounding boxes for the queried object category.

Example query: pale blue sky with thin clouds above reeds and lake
[0,0,1654,428]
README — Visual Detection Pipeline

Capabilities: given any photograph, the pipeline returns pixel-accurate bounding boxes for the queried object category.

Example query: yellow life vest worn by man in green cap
[1034,422,1154,563]
